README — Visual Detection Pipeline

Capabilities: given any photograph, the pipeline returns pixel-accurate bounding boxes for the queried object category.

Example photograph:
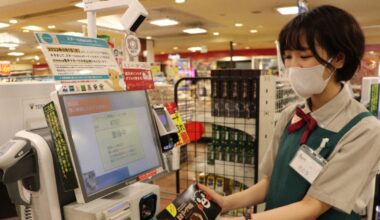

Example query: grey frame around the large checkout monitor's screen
[58,91,163,203]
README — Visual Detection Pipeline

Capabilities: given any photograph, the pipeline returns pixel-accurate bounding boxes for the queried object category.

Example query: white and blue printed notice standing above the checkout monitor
[35,32,125,93]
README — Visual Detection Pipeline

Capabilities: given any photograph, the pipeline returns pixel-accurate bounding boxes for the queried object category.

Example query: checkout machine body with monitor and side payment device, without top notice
[0,91,178,220]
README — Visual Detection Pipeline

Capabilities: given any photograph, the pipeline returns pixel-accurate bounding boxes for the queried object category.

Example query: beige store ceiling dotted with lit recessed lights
[0,0,380,60]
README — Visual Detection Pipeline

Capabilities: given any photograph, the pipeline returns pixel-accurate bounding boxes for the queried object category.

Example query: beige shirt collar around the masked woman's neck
[304,84,351,127]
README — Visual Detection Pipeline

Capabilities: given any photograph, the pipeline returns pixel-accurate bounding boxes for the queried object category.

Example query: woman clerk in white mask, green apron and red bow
[200,6,380,220]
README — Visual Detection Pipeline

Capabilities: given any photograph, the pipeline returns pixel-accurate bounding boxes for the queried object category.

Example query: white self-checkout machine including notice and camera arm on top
[0,0,168,220]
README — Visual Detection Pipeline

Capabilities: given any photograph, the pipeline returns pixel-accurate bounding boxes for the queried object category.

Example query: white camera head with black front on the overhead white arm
[121,0,148,32]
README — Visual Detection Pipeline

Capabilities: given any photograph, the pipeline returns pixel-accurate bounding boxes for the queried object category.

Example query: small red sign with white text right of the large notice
[123,68,154,90]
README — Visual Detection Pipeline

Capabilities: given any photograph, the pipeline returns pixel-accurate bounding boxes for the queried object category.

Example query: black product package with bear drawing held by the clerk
[157,184,222,220]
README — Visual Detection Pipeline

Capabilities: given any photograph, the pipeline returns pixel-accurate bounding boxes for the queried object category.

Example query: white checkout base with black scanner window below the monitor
[63,182,160,220]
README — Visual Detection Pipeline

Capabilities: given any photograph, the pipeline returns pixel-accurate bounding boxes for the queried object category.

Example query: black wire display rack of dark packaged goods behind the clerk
[175,70,299,216]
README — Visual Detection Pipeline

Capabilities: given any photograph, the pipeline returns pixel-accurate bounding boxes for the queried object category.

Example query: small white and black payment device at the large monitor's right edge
[153,105,180,171]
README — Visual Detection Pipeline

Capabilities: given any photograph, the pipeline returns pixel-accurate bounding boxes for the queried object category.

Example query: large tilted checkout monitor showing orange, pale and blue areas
[62,91,161,200]
